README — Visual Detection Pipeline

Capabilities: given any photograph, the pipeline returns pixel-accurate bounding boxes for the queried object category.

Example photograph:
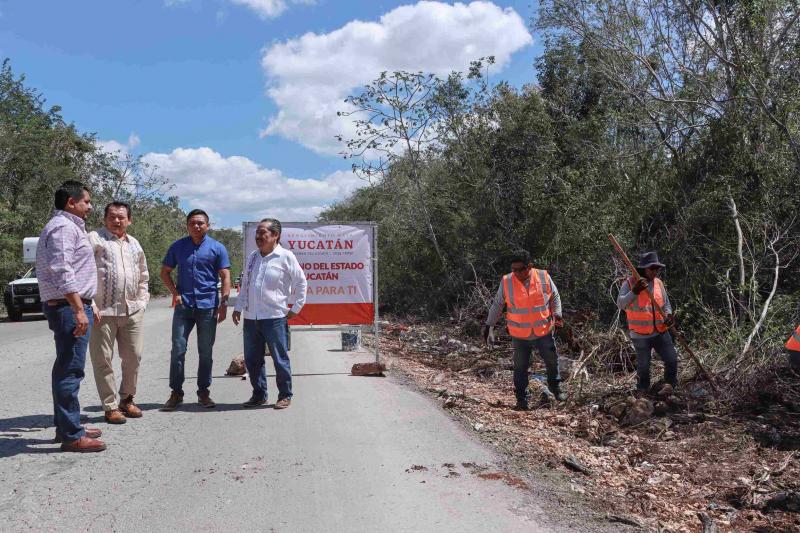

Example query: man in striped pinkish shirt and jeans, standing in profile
[36,181,106,452]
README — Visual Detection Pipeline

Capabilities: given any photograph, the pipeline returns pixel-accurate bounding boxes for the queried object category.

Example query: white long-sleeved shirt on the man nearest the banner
[234,244,307,320]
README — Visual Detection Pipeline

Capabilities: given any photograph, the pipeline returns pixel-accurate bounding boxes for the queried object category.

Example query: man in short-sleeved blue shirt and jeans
[161,209,231,411]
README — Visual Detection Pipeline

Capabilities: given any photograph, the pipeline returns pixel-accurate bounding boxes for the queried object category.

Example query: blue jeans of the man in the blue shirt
[169,304,217,394]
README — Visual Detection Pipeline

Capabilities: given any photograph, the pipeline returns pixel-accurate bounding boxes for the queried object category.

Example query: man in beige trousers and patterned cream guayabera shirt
[89,202,150,424]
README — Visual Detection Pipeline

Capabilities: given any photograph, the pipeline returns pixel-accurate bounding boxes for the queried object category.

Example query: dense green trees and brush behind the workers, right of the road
[330,0,800,362]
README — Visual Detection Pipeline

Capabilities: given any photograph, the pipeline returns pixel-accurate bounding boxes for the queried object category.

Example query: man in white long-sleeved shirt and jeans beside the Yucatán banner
[231,218,307,409]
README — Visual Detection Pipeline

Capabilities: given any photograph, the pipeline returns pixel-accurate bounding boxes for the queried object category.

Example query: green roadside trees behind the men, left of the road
[0,59,242,312]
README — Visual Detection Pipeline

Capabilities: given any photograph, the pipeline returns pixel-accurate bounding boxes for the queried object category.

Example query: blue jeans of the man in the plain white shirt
[244,318,292,400]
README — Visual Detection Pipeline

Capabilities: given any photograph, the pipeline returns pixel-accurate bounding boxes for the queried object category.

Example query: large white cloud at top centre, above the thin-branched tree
[262,0,533,154]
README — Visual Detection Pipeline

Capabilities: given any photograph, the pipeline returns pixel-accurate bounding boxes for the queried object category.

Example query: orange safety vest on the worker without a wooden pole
[502,268,553,339]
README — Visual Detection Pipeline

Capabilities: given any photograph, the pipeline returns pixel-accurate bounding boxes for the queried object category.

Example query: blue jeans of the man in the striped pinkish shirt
[42,303,94,442]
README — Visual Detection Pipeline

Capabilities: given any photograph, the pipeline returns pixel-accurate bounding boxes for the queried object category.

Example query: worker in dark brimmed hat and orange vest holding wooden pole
[617,252,678,391]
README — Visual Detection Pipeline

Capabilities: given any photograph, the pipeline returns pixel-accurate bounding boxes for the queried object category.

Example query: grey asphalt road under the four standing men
[0,299,592,532]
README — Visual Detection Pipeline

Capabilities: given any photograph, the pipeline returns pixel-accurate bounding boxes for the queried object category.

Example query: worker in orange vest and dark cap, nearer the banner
[482,250,566,411]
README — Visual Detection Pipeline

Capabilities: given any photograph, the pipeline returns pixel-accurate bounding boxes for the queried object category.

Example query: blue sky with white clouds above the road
[0,0,541,228]
